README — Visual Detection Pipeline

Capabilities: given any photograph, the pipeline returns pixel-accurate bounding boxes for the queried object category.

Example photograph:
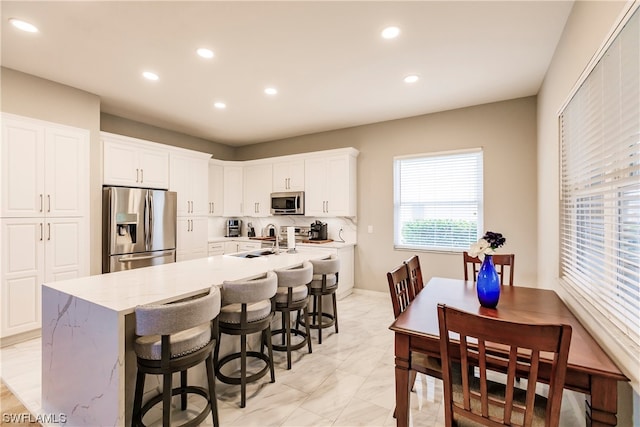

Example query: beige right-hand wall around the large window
[536,1,640,426]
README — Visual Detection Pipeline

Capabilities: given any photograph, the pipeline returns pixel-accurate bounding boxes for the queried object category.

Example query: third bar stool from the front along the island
[271,261,313,369]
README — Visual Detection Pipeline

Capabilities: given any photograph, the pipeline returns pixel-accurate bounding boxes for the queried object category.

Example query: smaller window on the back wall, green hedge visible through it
[394,149,482,251]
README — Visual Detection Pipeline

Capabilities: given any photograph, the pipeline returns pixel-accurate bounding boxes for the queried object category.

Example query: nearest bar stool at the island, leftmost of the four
[131,287,220,427]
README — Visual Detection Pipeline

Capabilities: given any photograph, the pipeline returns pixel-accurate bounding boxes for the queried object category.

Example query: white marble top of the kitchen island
[43,249,331,314]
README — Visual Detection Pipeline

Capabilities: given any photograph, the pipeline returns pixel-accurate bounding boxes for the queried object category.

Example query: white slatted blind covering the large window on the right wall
[560,10,640,359]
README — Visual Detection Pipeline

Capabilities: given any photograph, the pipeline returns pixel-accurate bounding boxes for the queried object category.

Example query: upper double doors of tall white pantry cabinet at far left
[0,114,89,218]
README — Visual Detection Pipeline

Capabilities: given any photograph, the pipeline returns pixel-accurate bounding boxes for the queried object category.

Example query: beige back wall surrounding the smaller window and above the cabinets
[236,97,537,292]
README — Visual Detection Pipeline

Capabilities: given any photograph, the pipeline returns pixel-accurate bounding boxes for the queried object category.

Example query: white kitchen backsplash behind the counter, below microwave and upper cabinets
[209,215,357,243]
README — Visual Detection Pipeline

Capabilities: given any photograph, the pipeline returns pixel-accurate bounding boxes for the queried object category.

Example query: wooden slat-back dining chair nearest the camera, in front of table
[438,304,571,427]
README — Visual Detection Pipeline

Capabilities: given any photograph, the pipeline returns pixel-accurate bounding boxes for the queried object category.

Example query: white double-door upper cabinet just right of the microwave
[304,148,358,217]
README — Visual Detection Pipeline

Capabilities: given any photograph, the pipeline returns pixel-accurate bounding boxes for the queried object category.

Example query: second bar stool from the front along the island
[214,271,278,408]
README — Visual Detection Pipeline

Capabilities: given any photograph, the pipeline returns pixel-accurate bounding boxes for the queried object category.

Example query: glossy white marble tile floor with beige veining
[0,291,585,427]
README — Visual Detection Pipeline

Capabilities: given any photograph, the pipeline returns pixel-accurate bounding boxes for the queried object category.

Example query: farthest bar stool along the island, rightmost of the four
[298,255,340,344]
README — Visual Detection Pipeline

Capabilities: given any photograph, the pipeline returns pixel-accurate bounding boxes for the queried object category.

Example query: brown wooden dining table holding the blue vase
[390,277,629,427]
